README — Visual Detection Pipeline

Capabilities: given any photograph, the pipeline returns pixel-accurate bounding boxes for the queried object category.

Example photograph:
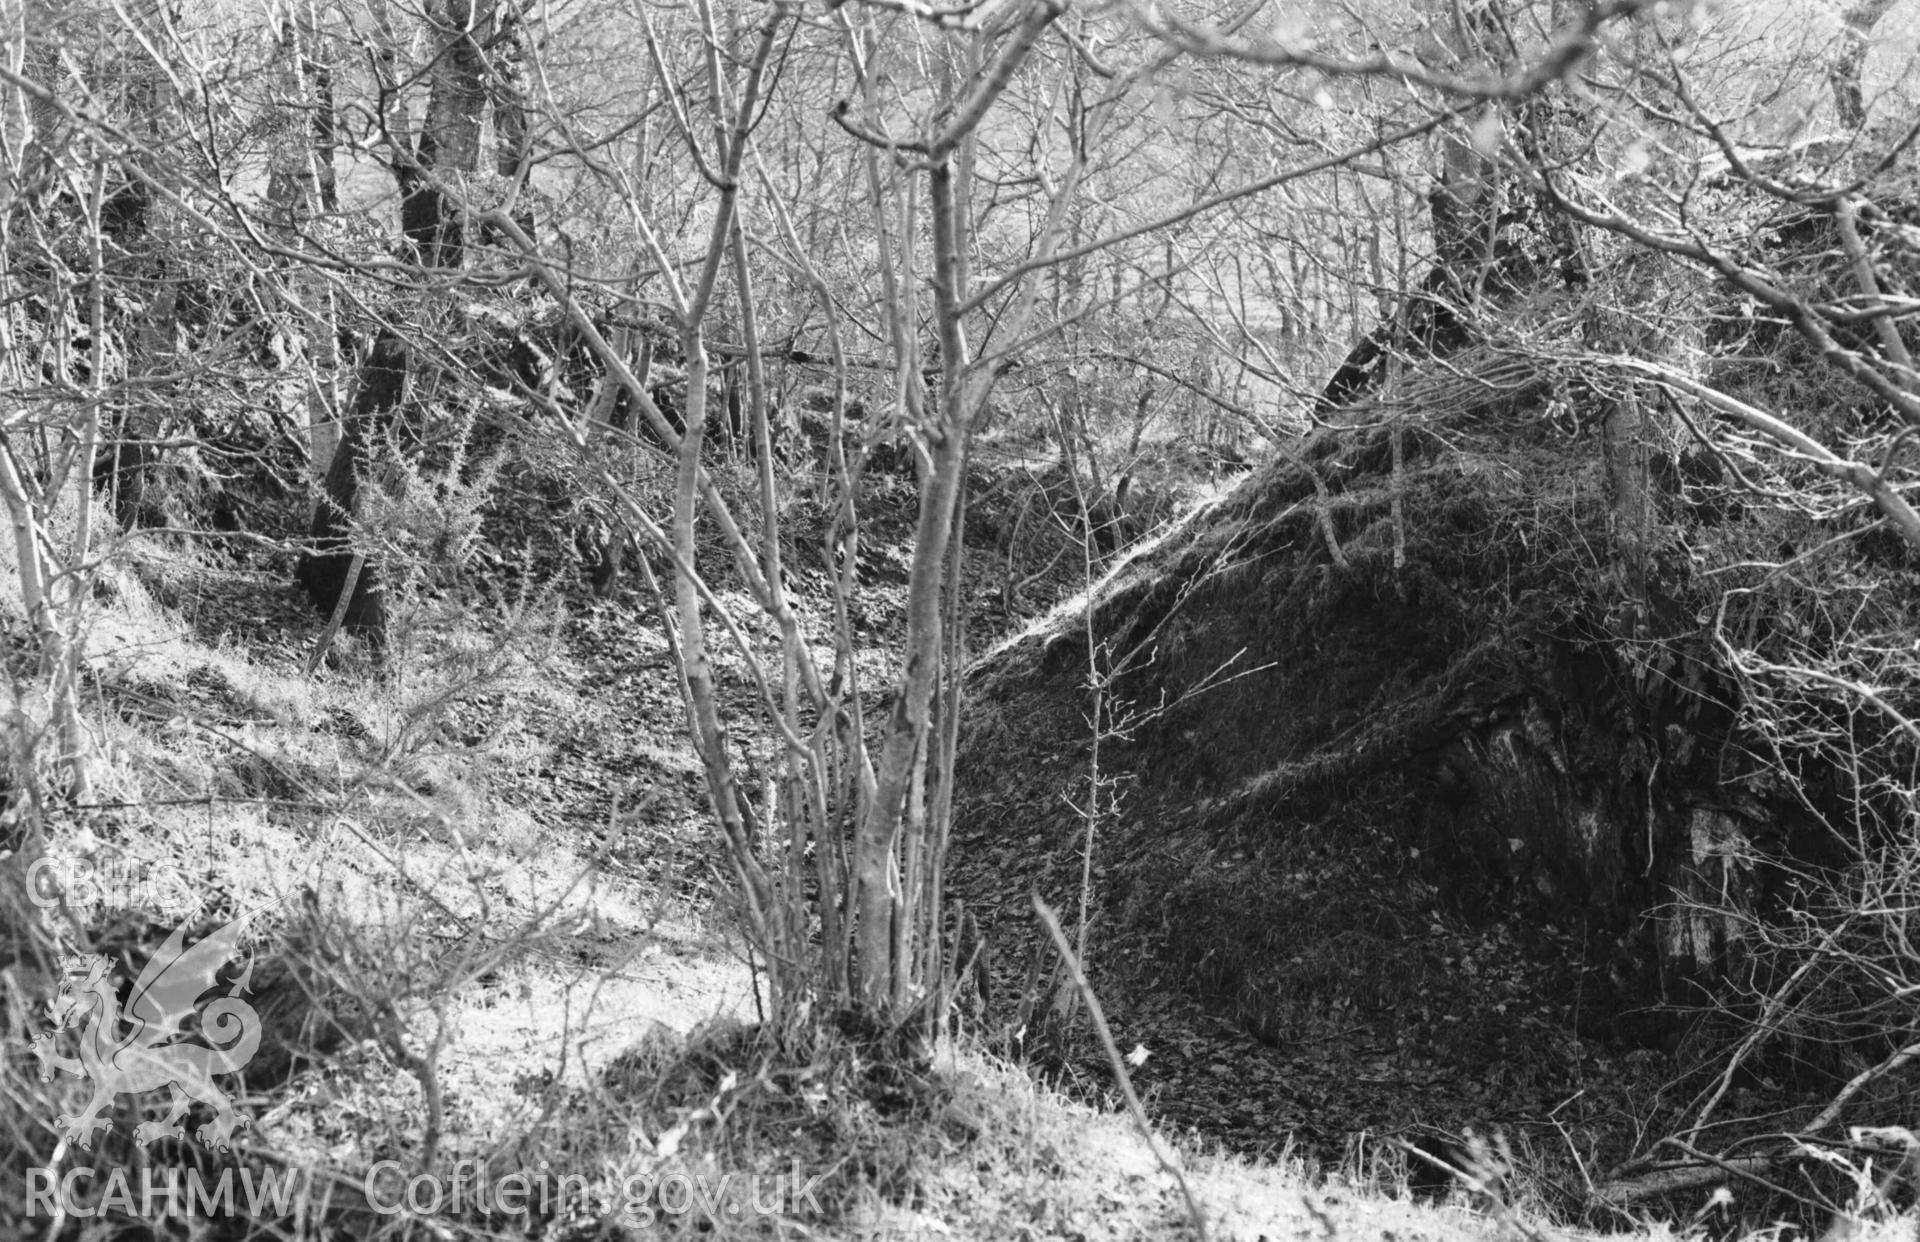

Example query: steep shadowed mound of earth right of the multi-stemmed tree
[952,376,1873,1174]
